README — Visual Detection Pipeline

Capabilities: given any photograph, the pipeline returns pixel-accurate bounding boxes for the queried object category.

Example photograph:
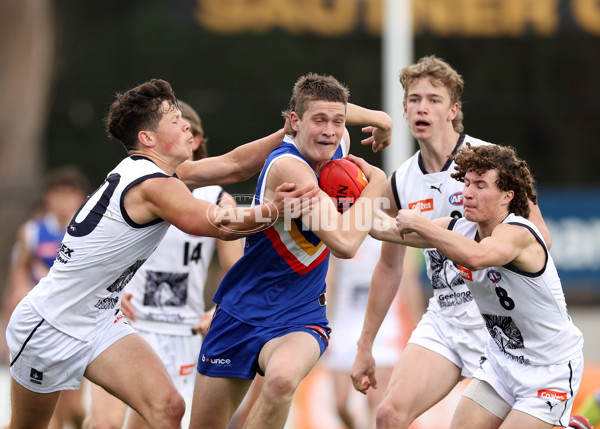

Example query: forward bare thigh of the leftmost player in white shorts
[85,334,178,414]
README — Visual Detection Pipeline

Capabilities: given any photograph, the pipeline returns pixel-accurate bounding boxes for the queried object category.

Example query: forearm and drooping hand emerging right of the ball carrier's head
[346,103,393,152]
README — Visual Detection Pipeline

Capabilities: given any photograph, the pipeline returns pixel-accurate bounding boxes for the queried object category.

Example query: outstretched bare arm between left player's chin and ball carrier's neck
[177,128,285,189]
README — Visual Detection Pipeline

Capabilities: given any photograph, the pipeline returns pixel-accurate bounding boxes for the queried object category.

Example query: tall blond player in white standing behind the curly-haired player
[351,56,550,429]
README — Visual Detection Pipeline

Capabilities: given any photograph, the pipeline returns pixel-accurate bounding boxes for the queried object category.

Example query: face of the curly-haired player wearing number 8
[463,170,512,222]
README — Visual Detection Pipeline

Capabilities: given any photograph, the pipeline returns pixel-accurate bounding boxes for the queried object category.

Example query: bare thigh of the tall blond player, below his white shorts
[385,344,461,415]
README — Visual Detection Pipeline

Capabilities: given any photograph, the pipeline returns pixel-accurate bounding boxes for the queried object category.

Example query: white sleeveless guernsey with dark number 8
[449,214,583,365]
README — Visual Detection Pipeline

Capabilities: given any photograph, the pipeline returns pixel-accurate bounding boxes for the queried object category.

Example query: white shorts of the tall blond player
[408,311,489,378]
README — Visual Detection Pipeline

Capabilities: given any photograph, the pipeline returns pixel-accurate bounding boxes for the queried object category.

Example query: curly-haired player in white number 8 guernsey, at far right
[388,145,583,429]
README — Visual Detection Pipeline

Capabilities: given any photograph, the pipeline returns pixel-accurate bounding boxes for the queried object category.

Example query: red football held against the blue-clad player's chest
[319,158,367,213]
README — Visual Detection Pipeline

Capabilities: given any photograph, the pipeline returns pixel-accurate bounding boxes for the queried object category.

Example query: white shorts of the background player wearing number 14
[138,330,202,397]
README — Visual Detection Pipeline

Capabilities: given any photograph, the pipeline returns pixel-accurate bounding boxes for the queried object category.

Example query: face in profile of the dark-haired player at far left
[152,101,194,163]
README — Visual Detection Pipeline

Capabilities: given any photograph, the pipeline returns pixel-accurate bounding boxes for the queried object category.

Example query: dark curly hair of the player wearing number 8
[450,143,537,218]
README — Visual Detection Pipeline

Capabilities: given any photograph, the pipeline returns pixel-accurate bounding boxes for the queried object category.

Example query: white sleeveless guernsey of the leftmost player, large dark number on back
[28,156,171,341]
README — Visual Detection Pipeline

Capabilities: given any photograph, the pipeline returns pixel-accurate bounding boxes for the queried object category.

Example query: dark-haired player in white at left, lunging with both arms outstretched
[6,79,318,429]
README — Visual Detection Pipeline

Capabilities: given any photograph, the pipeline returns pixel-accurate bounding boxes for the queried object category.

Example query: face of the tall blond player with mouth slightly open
[404,78,458,141]
